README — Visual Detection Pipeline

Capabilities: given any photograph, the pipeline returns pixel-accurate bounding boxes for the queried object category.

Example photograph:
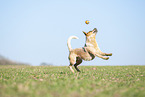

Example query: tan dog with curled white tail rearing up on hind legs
[67,28,112,73]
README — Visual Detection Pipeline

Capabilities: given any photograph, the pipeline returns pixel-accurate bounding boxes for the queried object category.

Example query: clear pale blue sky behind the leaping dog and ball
[0,0,145,66]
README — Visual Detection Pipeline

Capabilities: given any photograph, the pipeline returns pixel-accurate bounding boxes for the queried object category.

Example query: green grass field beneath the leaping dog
[0,65,145,97]
